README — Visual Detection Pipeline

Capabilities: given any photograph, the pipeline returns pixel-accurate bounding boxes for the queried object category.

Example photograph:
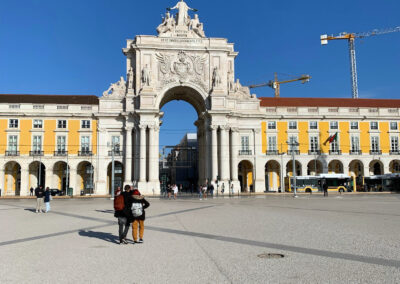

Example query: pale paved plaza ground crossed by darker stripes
[0,194,400,283]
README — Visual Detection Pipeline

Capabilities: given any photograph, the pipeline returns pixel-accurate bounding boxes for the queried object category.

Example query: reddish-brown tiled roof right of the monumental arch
[259,97,400,108]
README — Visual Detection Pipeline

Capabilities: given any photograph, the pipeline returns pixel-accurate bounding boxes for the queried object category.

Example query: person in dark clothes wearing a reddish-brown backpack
[114,185,131,244]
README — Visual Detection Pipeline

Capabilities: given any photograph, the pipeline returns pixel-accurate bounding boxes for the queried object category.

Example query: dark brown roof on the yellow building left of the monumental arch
[0,94,99,105]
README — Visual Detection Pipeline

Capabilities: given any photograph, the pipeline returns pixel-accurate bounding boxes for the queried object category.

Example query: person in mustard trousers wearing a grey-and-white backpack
[131,189,150,243]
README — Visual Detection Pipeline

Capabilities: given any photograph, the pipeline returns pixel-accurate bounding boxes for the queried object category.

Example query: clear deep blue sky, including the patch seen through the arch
[0,0,400,145]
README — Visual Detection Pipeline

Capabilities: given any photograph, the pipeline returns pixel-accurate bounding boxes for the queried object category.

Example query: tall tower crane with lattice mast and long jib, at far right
[320,27,400,99]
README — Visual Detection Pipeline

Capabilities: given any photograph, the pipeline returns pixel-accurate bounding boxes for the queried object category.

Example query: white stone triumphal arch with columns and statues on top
[99,1,264,193]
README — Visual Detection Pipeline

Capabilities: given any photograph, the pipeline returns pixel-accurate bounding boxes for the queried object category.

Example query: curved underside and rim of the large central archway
[156,83,208,115]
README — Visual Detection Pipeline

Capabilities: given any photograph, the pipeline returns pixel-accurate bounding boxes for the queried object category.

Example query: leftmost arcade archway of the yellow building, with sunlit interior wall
[1,161,21,196]
